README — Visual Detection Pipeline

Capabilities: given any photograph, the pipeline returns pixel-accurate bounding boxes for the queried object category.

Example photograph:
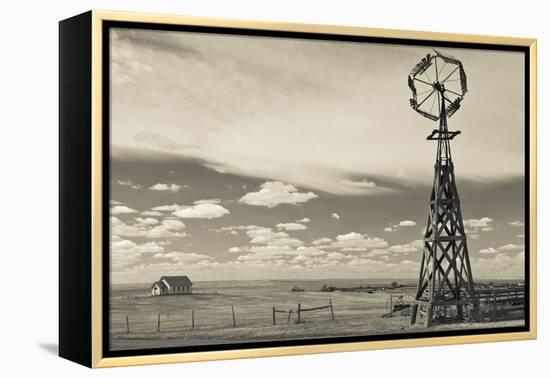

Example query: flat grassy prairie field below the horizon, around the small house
[110,280,523,350]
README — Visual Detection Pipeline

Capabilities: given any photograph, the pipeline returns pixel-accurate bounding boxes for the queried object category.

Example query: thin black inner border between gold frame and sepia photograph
[102,21,531,357]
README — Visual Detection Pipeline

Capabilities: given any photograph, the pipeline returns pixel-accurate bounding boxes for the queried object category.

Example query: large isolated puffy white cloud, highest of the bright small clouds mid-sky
[239,181,317,208]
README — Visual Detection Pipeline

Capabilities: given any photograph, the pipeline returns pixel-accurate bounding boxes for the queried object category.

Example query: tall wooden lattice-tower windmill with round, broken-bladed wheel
[408,50,479,327]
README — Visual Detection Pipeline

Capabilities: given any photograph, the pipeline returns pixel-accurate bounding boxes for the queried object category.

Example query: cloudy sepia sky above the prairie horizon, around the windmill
[110,29,525,283]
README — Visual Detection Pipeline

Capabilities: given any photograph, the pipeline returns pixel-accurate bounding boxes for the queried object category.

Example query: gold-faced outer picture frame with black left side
[60,10,537,368]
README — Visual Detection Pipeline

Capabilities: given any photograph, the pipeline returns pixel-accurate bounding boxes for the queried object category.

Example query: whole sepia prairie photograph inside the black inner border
[105,27,529,351]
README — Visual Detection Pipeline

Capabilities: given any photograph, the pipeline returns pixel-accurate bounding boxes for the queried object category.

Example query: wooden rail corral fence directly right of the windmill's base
[475,287,525,321]
